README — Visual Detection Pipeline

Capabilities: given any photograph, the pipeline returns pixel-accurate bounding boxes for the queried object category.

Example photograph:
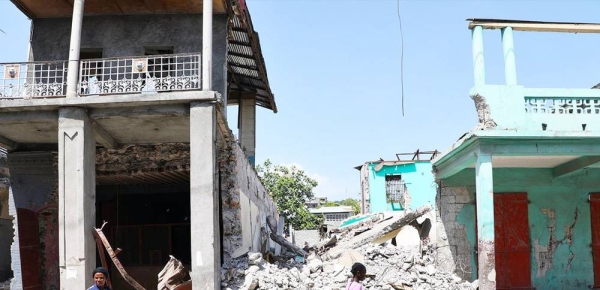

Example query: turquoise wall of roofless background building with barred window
[369,161,437,212]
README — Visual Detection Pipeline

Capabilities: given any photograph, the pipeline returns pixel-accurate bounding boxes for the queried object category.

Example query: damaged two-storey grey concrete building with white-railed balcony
[0,0,278,289]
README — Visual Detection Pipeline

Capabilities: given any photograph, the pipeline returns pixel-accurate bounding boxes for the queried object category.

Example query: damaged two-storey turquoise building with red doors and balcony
[432,19,600,289]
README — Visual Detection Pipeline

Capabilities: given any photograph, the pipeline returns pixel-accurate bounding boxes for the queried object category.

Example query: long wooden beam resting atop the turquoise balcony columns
[469,19,600,33]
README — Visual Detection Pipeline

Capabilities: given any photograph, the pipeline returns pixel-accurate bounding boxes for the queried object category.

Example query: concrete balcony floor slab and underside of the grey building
[0,91,215,150]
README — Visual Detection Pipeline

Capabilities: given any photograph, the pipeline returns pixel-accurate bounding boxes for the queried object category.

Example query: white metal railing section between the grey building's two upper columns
[79,53,201,96]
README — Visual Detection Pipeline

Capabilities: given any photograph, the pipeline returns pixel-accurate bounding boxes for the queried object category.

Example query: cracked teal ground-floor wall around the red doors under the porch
[441,168,600,289]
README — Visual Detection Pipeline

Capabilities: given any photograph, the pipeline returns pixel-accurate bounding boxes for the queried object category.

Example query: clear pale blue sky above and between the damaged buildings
[0,0,600,200]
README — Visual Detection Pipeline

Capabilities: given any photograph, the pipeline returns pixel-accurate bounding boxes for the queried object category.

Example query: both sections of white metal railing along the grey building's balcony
[0,53,202,100]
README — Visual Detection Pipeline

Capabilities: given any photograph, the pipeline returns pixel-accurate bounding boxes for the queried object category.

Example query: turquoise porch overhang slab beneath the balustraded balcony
[432,130,600,180]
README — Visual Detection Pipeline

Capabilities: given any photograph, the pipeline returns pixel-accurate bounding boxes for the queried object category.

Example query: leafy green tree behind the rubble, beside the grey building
[256,159,323,230]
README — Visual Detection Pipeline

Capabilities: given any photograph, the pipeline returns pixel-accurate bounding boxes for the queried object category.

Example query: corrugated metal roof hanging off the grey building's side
[227,0,277,113]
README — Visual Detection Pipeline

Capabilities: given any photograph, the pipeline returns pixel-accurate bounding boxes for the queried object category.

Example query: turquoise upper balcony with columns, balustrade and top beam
[469,19,600,137]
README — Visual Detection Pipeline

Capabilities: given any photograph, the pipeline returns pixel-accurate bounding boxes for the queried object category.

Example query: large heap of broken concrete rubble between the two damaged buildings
[221,206,478,290]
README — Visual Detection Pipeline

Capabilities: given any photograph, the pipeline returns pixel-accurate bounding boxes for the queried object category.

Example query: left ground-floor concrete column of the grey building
[58,108,96,289]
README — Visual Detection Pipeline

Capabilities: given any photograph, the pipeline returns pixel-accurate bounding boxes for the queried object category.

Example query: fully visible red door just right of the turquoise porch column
[494,193,531,289]
